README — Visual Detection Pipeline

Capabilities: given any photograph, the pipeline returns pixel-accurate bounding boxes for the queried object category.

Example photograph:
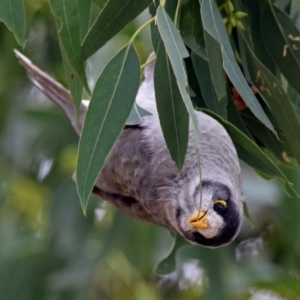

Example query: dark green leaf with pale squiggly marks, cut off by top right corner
[261,1,300,93]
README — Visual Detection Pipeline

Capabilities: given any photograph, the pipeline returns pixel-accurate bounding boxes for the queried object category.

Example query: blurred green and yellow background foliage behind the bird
[0,0,300,300]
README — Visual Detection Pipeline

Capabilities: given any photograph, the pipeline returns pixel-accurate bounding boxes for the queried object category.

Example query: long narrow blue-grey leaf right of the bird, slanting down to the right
[201,0,275,132]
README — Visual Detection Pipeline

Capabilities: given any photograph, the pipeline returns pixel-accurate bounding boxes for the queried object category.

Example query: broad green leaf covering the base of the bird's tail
[76,44,140,212]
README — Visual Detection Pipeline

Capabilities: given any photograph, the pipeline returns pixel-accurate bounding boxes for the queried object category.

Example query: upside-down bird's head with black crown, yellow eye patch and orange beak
[175,180,243,248]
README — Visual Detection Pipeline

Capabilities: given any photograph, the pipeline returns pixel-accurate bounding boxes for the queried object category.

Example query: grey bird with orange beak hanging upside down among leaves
[16,51,243,248]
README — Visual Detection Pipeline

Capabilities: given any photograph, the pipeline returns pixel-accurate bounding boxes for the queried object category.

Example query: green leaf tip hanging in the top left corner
[0,0,26,45]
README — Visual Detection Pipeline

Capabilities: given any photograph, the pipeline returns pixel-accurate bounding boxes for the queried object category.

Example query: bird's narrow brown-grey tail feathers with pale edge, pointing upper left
[14,50,86,134]
